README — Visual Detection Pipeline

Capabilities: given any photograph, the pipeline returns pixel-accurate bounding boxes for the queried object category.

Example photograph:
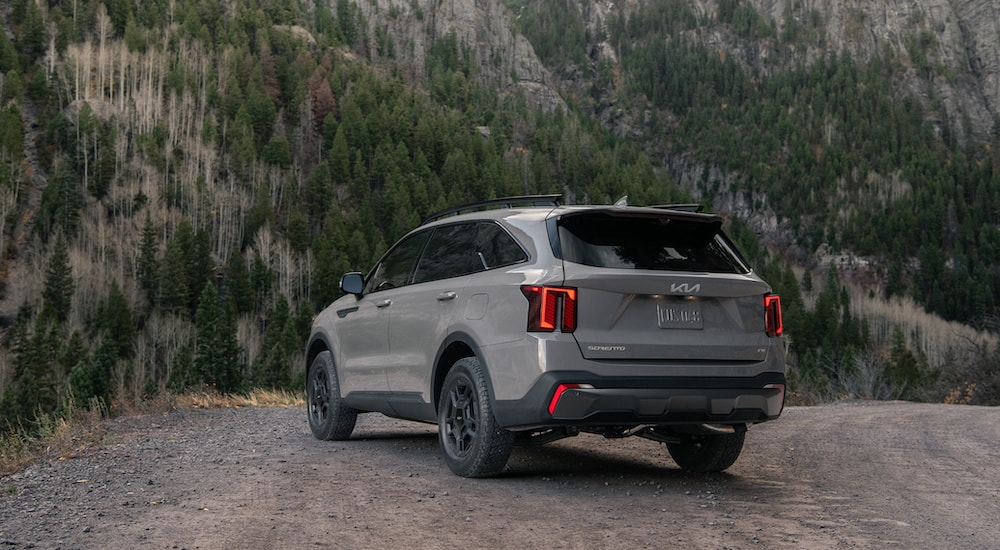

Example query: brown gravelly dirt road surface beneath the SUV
[0,402,1000,549]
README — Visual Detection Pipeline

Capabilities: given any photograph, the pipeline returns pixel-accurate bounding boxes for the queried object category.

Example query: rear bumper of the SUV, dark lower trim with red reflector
[495,371,785,429]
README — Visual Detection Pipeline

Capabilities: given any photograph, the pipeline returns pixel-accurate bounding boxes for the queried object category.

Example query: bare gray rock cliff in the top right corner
[696,0,1000,145]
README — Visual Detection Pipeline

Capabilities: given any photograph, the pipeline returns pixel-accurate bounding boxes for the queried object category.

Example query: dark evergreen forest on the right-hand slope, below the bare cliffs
[509,0,1000,403]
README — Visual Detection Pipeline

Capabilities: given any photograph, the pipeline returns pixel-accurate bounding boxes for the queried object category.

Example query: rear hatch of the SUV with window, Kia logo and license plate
[550,208,770,362]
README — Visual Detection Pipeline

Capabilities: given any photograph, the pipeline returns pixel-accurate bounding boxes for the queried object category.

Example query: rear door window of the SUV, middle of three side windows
[413,223,484,283]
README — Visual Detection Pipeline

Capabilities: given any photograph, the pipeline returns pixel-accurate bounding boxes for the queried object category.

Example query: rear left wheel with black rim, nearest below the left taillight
[438,357,514,477]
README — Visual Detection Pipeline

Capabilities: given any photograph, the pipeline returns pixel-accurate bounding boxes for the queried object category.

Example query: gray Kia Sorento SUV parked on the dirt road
[306,196,785,477]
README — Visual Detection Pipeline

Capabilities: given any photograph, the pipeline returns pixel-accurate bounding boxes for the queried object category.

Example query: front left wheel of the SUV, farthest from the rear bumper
[306,351,358,440]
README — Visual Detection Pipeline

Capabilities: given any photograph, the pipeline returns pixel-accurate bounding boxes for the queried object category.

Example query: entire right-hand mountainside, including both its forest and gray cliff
[508,0,1000,406]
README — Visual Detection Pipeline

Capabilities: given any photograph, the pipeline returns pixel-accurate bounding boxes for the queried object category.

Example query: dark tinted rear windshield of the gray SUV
[556,212,749,273]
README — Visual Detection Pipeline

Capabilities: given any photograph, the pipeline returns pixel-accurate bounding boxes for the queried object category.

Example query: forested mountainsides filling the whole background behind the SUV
[0,0,1000,432]
